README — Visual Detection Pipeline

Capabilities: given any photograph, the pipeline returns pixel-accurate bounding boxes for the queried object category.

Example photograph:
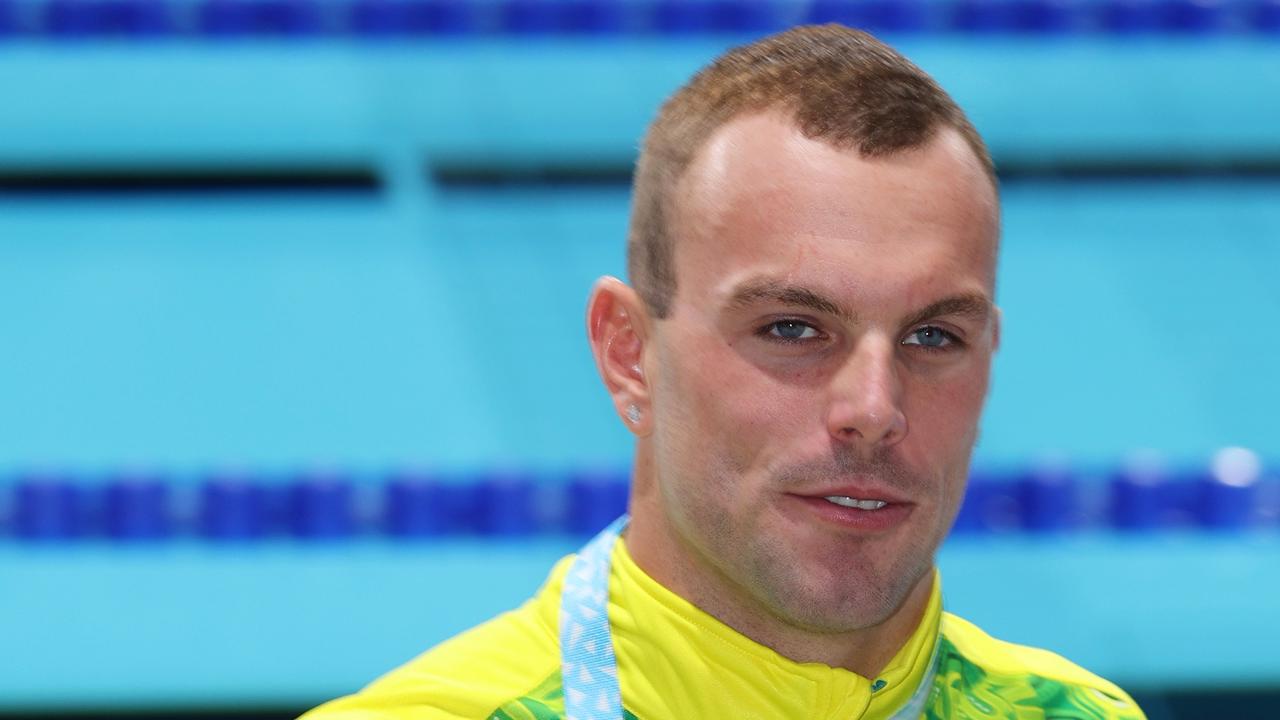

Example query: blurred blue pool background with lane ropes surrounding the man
[0,0,1280,720]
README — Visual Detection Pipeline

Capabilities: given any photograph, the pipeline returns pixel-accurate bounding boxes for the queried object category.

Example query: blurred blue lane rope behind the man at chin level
[0,451,1280,542]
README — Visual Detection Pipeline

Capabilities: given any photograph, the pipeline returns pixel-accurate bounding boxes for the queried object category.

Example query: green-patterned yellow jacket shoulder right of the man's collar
[938,612,1144,720]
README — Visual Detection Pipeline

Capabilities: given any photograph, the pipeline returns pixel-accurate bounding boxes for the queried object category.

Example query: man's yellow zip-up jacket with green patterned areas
[302,541,1144,720]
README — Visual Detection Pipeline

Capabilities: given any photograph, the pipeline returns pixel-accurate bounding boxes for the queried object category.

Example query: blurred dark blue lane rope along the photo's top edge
[0,0,1280,38]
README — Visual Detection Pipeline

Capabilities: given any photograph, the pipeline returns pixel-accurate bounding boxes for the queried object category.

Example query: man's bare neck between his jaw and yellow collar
[626,454,934,678]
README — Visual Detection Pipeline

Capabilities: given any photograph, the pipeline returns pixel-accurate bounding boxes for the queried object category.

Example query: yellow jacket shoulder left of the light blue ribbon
[301,559,568,720]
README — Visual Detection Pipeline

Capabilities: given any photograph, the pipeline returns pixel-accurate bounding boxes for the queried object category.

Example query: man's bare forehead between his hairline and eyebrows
[672,113,998,304]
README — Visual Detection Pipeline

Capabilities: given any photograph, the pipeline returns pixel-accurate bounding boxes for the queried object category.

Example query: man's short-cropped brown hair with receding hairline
[627,24,995,318]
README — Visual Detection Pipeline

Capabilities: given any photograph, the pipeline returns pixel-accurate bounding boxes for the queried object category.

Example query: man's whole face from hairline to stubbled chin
[645,113,998,632]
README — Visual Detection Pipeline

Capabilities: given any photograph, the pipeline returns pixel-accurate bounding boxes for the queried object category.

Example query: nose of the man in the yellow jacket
[827,337,908,450]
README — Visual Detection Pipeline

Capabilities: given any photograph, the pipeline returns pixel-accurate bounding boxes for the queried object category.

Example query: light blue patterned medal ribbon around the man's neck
[559,515,942,720]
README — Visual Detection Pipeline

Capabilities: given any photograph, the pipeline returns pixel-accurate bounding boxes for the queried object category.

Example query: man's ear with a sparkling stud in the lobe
[586,277,653,437]
